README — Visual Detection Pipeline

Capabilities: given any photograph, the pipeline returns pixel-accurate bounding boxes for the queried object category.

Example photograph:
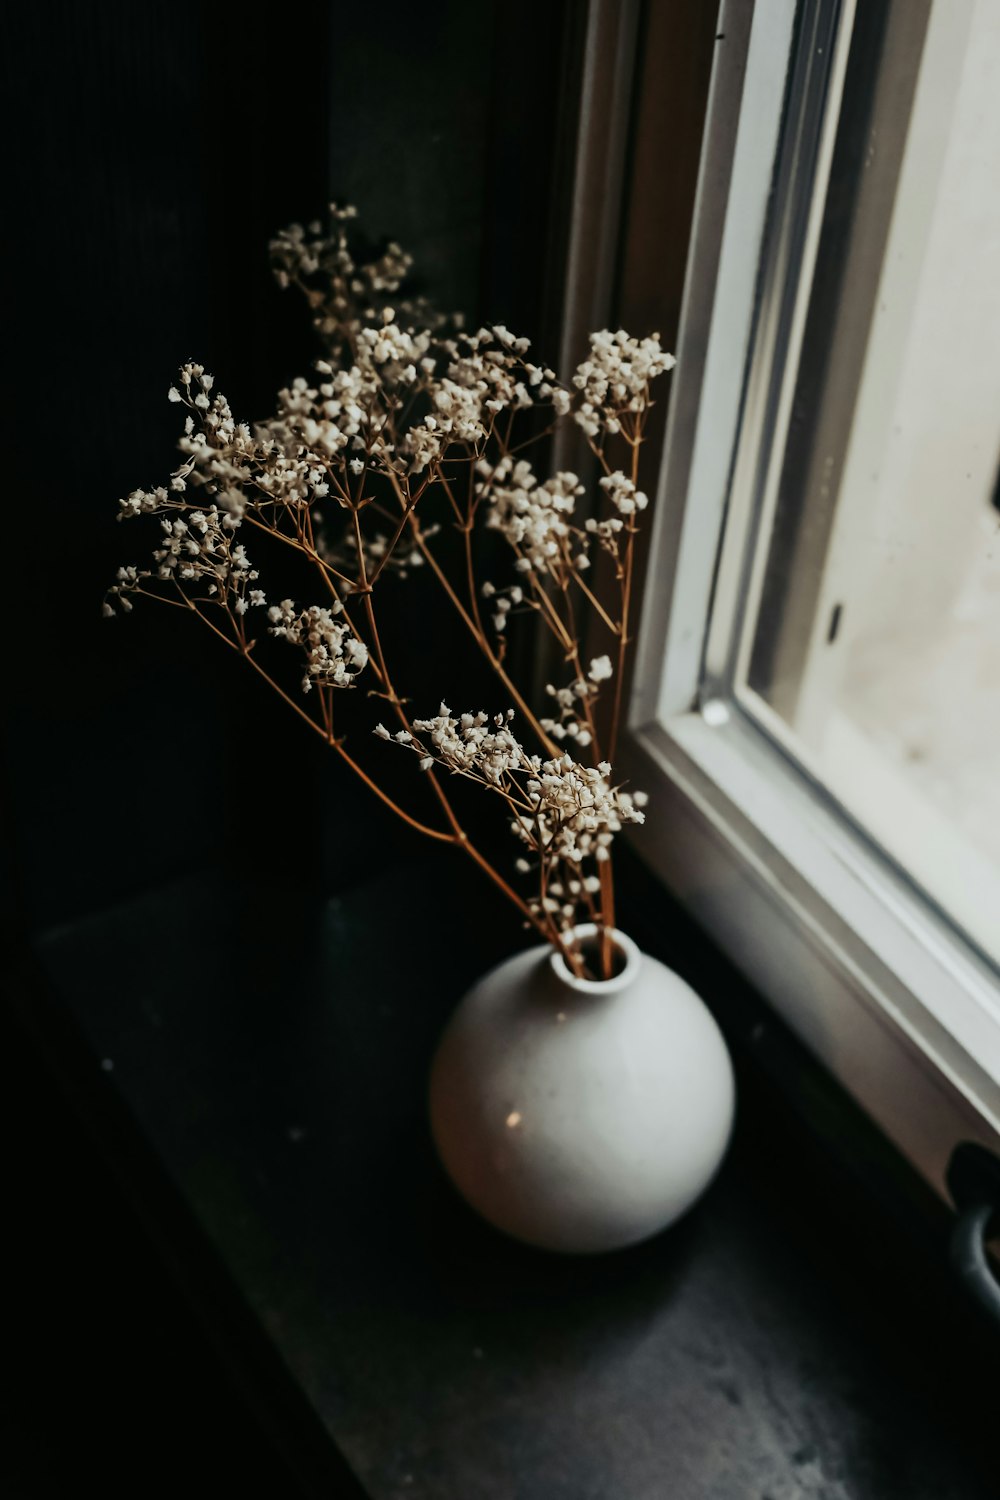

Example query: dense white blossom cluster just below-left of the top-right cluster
[478,458,586,573]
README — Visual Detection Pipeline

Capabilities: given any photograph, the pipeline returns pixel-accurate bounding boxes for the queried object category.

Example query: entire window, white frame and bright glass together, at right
[628,0,1000,1185]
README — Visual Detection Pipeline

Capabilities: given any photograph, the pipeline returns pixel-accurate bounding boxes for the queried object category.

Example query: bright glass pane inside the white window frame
[736,0,1000,959]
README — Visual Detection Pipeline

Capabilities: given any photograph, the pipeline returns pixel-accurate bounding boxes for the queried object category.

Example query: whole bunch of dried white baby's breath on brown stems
[105,207,673,975]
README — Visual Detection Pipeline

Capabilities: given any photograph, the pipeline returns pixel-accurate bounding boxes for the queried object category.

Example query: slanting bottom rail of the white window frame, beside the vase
[625,705,1000,1194]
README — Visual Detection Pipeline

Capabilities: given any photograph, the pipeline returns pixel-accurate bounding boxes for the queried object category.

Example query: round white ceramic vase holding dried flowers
[430,926,735,1254]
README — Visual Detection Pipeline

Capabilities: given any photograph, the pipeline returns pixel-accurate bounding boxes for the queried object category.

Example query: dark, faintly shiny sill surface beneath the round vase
[11,863,1000,1500]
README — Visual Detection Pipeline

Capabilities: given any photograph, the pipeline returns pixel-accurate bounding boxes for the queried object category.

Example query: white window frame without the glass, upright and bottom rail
[621,0,1000,1194]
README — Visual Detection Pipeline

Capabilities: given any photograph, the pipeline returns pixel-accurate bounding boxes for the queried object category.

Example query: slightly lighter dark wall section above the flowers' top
[330,0,586,339]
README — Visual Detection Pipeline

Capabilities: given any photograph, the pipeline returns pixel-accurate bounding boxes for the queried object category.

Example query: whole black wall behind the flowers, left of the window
[1,0,565,926]
